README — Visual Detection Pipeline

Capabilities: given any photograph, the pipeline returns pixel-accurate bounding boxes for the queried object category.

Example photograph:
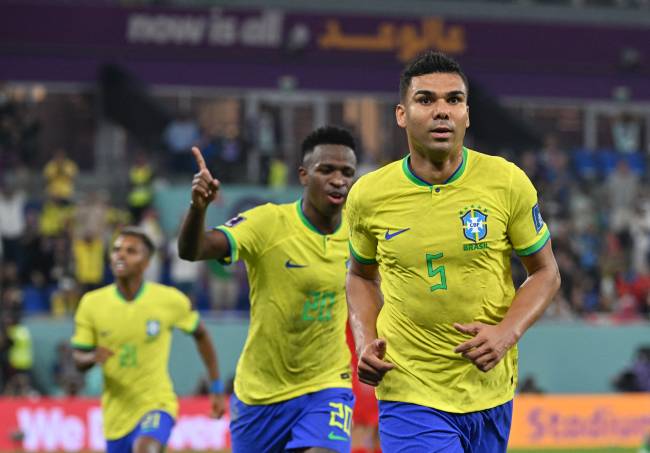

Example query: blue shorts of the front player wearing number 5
[379,401,512,453]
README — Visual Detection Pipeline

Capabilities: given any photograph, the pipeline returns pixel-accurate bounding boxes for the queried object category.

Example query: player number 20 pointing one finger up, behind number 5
[179,126,356,453]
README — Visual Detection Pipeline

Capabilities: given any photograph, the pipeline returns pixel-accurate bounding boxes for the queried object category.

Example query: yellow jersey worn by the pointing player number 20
[217,200,351,404]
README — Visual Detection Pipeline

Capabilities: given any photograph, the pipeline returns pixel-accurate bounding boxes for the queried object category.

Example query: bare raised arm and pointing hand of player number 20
[178,147,229,261]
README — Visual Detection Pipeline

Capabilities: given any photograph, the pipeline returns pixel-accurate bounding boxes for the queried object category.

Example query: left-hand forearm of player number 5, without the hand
[346,272,382,354]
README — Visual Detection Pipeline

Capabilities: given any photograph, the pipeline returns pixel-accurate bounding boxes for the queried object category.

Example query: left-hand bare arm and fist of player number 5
[345,258,394,386]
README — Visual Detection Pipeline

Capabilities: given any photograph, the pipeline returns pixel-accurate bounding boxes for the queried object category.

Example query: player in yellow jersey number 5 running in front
[346,52,560,453]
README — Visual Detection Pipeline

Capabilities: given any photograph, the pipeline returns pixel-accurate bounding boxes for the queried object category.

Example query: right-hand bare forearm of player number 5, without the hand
[500,266,560,342]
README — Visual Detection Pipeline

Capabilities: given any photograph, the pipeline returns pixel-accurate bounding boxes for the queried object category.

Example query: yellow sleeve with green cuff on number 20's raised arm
[215,203,277,264]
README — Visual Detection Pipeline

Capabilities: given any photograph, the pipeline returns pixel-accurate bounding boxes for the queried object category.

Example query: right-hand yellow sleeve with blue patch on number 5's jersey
[508,165,550,256]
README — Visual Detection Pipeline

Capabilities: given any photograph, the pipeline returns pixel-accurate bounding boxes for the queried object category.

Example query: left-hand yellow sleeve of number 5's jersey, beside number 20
[345,181,377,264]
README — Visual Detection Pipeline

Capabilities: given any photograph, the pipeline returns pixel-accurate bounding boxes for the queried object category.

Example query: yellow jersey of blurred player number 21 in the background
[72,282,199,440]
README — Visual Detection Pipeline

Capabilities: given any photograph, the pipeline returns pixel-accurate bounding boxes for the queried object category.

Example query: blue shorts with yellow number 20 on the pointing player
[230,388,354,453]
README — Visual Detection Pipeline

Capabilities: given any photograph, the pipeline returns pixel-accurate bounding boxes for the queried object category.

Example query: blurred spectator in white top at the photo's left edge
[0,181,26,263]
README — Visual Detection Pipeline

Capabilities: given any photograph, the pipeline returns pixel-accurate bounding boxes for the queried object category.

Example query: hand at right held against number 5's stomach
[454,322,517,372]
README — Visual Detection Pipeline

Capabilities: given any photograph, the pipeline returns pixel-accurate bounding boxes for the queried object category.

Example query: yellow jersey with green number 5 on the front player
[346,148,549,413]
